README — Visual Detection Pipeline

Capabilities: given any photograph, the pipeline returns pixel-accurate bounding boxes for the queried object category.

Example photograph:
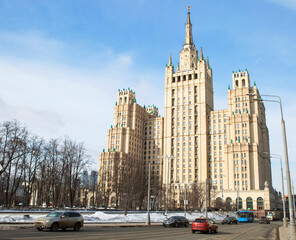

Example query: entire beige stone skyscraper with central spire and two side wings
[98,8,281,210]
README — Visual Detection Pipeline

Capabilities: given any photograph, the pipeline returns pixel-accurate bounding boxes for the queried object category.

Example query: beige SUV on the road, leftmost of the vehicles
[34,211,84,231]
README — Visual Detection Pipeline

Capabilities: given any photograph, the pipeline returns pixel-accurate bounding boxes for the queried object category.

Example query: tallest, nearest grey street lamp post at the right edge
[247,94,296,240]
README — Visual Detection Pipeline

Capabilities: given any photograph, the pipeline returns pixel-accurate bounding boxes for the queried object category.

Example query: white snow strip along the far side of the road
[0,211,235,223]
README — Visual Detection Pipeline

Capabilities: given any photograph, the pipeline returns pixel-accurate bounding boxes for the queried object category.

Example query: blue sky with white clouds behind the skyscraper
[0,0,296,194]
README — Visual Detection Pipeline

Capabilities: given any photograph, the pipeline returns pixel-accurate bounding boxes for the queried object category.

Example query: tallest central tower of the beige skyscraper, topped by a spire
[163,7,214,204]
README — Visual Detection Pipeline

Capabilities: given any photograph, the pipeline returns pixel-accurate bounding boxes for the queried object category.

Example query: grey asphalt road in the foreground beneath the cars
[0,222,282,240]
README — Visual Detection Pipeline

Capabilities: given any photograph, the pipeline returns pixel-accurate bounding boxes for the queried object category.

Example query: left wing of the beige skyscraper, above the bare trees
[98,89,164,207]
